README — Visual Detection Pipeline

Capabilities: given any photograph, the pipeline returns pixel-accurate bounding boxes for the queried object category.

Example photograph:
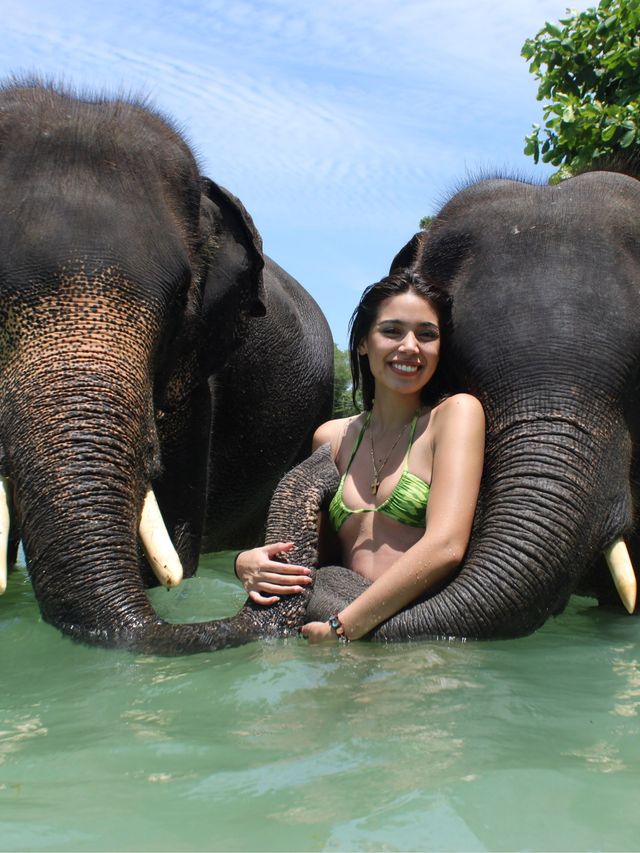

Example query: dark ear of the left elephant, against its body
[199,177,266,373]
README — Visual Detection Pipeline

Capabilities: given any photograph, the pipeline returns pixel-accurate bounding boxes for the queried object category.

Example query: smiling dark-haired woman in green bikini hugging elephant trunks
[236,270,485,643]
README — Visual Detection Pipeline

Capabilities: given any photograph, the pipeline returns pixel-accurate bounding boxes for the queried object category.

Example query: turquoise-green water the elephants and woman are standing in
[0,555,640,851]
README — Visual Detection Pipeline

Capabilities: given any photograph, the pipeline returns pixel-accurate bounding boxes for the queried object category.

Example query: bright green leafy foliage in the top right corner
[522,0,640,182]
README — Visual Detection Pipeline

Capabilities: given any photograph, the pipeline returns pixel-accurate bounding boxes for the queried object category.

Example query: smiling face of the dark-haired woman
[358,290,440,394]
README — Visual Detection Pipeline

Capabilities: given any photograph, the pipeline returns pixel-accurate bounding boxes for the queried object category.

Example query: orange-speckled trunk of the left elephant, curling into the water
[0,326,253,654]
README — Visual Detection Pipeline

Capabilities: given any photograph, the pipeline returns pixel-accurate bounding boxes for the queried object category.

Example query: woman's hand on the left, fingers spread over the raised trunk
[235,542,311,606]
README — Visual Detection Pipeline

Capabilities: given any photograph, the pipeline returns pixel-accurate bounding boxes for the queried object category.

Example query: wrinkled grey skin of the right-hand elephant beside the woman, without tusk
[272,171,640,640]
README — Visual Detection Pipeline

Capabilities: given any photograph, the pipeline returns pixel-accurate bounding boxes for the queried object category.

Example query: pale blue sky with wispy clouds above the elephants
[0,0,597,347]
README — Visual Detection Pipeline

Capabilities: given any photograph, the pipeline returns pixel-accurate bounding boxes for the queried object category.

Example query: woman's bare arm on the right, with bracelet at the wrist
[302,394,485,642]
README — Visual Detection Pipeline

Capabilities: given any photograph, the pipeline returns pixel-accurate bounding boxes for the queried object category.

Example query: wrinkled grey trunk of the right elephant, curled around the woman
[307,414,631,641]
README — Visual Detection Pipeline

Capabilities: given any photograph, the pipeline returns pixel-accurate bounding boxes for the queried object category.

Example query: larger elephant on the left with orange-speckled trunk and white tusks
[0,80,333,654]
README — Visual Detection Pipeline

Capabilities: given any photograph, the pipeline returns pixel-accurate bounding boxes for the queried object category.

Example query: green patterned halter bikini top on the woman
[329,412,430,531]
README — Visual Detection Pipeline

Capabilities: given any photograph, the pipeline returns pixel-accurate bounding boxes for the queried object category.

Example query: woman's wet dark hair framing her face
[349,269,451,411]
